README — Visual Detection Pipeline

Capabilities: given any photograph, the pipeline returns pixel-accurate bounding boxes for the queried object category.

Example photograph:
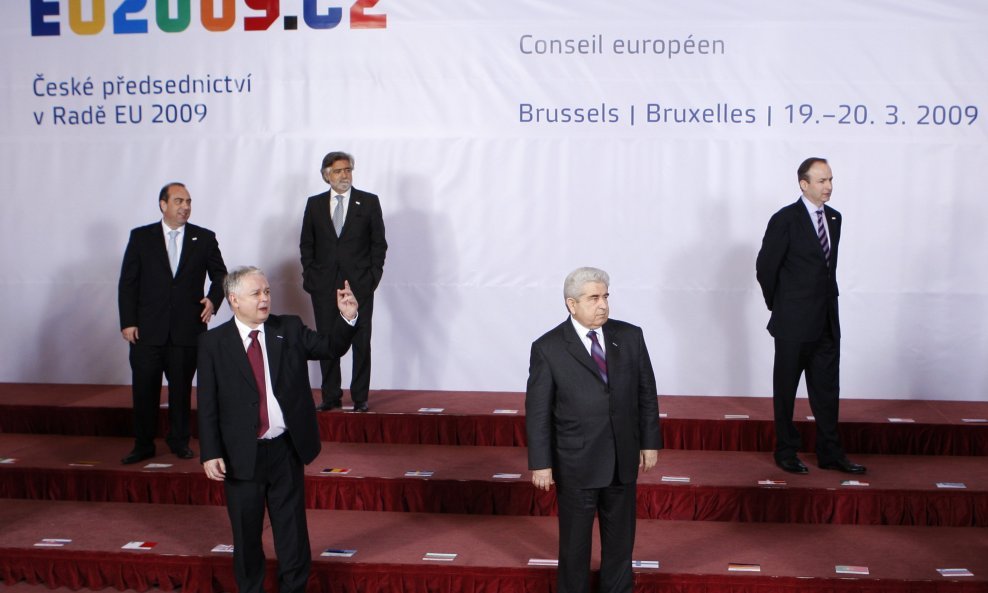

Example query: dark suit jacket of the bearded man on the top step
[299,188,388,303]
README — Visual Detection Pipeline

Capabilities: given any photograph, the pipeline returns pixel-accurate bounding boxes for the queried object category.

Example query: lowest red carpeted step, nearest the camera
[0,500,988,593]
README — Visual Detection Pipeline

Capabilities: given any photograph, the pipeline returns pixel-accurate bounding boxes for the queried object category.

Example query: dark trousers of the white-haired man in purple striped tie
[556,480,637,593]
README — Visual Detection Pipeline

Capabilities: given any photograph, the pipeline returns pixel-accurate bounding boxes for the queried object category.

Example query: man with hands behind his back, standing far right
[755,158,865,474]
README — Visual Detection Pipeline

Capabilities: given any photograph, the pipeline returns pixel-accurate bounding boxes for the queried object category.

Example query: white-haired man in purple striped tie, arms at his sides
[525,268,662,593]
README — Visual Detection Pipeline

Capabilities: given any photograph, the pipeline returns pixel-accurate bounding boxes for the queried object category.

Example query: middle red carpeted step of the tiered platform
[0,435,988,527]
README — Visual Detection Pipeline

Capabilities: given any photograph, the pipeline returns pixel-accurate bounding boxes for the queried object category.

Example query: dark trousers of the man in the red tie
[224,433,312,593]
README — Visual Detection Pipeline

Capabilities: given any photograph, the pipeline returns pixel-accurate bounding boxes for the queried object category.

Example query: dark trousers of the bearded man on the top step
[312,290,374,404]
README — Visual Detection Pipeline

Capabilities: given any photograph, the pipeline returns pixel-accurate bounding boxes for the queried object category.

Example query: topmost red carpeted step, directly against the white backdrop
[0,383,988,455]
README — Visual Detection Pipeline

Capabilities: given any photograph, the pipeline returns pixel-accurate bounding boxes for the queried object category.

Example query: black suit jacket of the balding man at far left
[117,222,226,346]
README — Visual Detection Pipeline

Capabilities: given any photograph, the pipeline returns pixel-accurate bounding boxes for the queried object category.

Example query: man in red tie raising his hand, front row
[198,267,357,593]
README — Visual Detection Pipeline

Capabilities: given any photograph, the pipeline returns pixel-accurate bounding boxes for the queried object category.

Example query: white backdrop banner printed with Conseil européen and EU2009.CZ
[0,0,988,400]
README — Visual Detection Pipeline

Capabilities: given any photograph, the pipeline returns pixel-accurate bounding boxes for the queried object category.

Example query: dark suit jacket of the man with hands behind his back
[755,198,841,342]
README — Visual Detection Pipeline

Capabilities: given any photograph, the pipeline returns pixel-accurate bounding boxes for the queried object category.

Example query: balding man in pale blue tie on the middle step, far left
[118,183,226,464]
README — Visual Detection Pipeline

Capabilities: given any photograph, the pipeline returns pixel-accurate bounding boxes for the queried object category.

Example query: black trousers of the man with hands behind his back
[772,323,844,463]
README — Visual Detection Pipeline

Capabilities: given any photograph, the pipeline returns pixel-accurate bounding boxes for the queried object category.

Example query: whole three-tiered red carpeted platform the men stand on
[0,384,988,593]
